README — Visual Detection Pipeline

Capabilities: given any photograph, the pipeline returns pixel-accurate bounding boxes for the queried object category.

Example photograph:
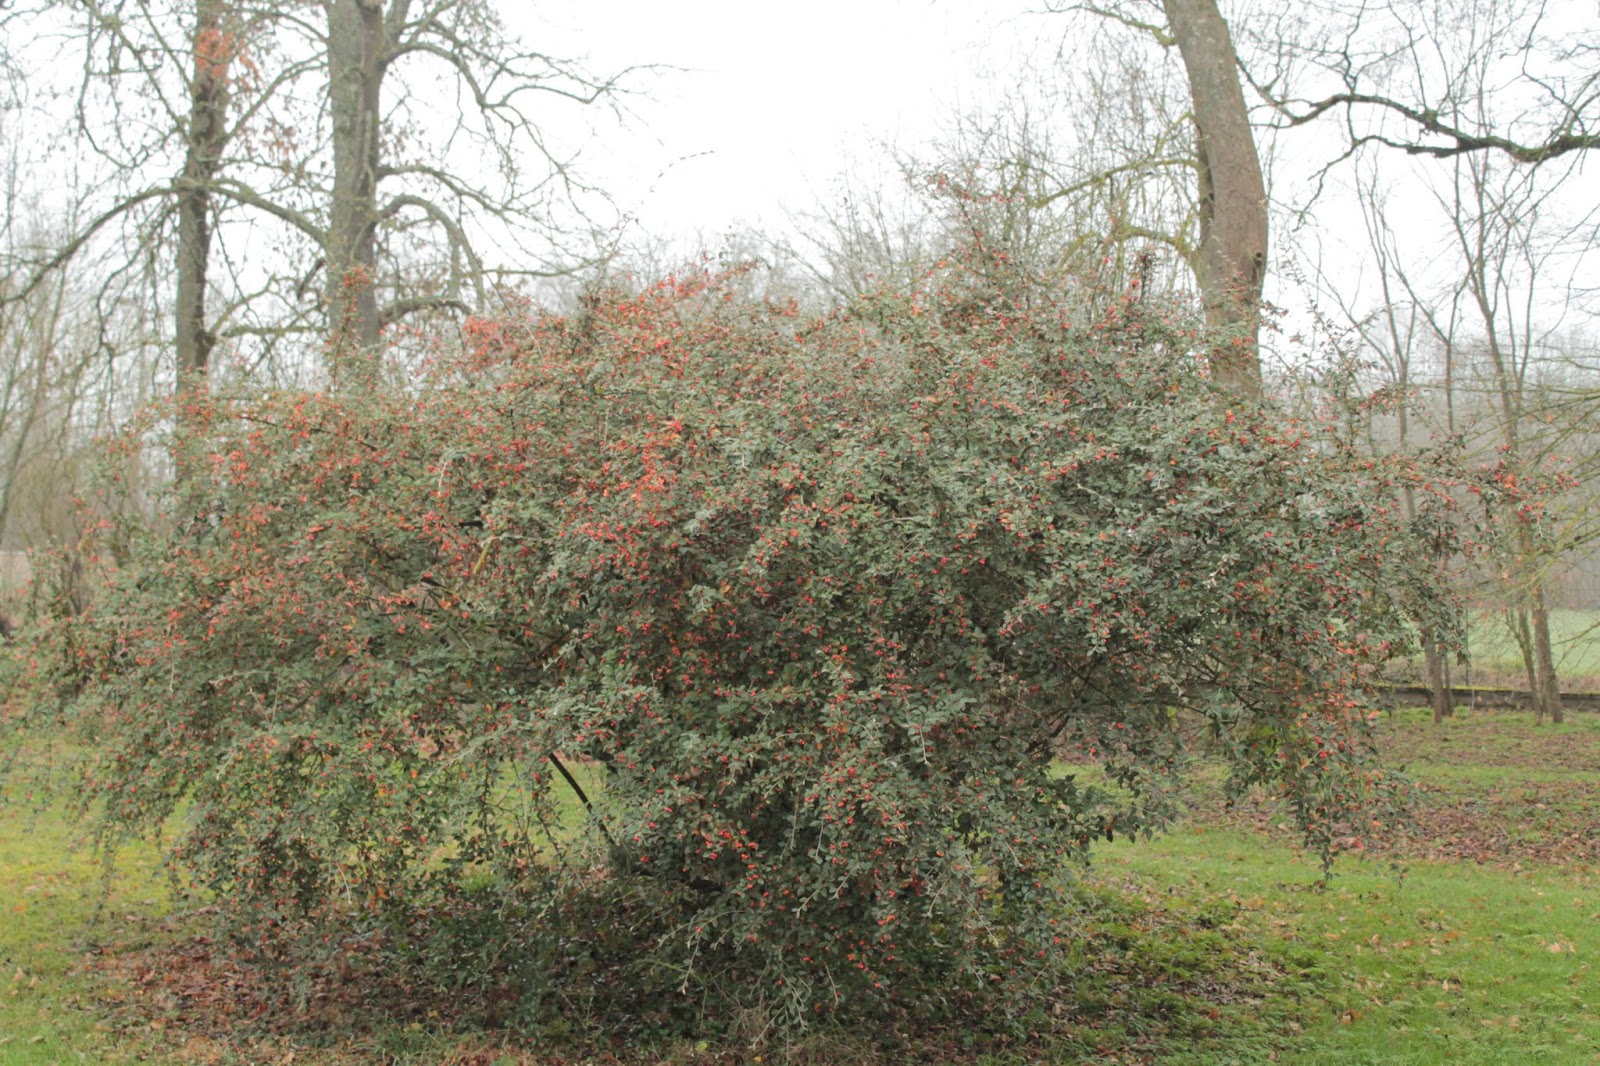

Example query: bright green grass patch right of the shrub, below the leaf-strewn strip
[1099,831,1600,1066]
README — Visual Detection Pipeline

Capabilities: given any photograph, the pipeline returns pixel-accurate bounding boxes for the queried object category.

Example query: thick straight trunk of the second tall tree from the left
[325,0,387,385]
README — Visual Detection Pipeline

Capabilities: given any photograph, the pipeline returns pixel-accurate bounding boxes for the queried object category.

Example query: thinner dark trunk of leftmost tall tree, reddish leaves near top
[174,0,237,403]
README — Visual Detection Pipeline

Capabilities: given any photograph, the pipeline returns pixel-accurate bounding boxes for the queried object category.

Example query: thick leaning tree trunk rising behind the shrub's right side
[1165,0,1267,395]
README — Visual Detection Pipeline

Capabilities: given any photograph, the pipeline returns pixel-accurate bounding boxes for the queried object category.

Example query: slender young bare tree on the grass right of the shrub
[1299,135,1597,720]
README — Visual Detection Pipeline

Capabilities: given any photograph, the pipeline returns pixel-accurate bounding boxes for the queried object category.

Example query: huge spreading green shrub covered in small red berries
[6,259,1459,1023]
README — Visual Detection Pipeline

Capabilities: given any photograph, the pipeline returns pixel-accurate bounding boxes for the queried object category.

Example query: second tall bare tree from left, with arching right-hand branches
[318,0,621,381]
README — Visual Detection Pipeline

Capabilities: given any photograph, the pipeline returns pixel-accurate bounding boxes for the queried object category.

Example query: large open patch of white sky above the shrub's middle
[521,0,1059,240]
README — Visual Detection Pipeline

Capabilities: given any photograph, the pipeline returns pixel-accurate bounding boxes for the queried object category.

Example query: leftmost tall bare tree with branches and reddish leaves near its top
[10,0,304,387]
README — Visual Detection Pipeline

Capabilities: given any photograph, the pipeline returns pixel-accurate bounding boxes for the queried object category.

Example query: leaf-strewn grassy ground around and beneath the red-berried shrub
[0,714,1600,1066]
